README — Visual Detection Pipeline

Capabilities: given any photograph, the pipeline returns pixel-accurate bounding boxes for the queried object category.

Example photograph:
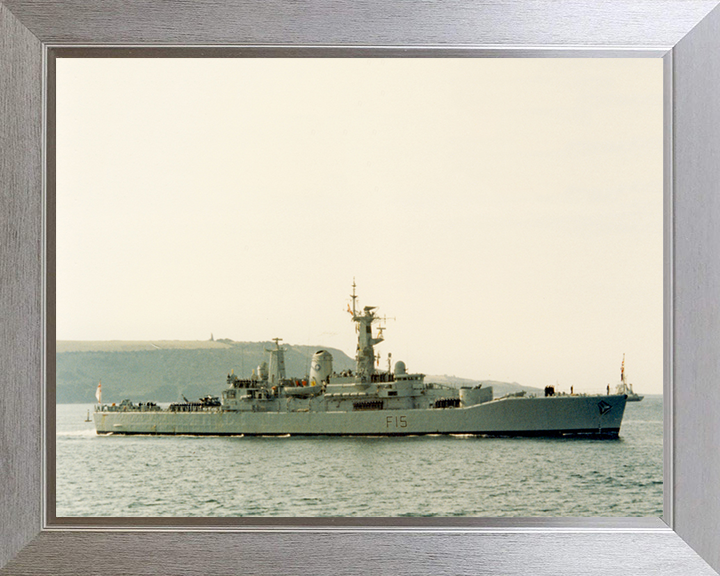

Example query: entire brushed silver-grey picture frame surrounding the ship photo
[0,0,720,576]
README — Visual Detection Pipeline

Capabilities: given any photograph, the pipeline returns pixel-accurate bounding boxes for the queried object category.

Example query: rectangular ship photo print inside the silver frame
[55,58,663,518]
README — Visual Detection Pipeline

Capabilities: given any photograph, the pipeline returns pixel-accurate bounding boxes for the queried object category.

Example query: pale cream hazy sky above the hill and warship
[57,58,663,394]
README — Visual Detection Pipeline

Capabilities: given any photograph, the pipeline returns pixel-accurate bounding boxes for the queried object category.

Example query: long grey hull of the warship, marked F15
[94,395,626,438]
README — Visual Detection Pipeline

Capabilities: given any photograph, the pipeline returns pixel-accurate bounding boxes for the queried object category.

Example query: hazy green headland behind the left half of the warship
[55,340,355,404]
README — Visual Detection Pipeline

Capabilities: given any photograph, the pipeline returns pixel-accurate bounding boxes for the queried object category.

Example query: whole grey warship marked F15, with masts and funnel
[93,282,627,438]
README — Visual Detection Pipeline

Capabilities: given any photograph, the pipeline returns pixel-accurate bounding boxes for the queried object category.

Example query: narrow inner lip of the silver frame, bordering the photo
[40,43,675,533]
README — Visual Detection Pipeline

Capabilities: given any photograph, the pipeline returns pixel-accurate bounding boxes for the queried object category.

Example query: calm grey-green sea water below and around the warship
[56,396,663,517]
